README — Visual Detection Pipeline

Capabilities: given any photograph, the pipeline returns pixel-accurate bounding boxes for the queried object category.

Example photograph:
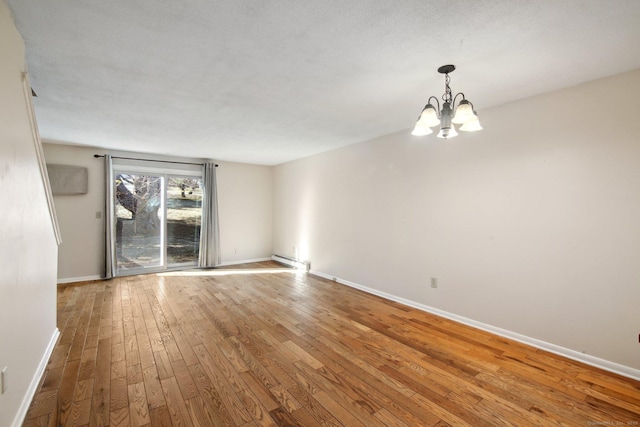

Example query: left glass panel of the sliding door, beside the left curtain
[114,173,165,274]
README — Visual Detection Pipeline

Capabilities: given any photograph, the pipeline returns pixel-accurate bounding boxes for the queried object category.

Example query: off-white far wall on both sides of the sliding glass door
[44,143,272,282]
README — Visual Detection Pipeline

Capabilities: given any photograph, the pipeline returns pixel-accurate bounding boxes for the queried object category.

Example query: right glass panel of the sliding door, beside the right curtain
[167,177,202,266]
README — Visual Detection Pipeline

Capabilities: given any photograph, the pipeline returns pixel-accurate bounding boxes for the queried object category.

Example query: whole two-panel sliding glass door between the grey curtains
[113,168,202,276]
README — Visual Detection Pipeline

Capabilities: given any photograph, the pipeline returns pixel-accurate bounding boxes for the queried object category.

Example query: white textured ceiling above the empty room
[7,0,640,165]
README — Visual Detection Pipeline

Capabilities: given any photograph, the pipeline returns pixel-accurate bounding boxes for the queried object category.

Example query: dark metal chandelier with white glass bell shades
[411,65,482,139]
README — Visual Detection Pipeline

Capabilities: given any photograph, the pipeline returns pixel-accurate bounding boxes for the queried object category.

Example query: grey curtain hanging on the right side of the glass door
[198,163,220,267]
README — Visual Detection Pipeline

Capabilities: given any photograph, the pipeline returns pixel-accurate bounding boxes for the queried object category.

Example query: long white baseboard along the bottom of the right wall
[309,270,640,380]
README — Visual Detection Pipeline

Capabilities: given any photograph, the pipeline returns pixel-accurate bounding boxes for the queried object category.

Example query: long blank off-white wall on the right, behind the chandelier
[274,70,640,369]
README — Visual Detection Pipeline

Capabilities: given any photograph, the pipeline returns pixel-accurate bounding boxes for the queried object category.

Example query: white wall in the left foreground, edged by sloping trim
[0,0,57,426]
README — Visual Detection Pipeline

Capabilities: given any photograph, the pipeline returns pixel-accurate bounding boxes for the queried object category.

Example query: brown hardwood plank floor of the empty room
[24,264,640,427]
